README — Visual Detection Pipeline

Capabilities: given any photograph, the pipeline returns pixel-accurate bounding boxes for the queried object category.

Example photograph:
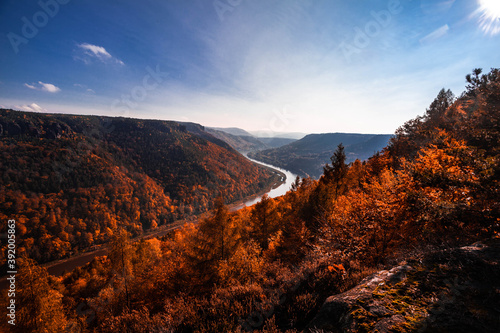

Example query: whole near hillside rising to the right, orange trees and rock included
[0,69,500,333]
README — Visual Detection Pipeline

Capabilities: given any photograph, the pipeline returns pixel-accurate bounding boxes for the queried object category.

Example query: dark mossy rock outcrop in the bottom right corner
[308,239,500,333]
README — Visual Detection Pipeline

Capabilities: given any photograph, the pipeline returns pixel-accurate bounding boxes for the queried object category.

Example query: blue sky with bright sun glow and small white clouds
[0,0,500,136]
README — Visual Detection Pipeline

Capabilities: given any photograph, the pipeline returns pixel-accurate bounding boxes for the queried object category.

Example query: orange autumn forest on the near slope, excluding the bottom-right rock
[0,69,500,332]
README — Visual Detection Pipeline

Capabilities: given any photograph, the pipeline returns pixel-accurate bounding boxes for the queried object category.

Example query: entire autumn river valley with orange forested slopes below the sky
[0,70,500,333]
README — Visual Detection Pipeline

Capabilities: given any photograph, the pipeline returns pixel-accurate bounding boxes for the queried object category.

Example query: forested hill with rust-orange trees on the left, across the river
[0,109,273,261]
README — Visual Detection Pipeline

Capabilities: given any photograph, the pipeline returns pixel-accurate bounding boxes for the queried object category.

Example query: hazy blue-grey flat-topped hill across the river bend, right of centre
[249,133,392,178]
